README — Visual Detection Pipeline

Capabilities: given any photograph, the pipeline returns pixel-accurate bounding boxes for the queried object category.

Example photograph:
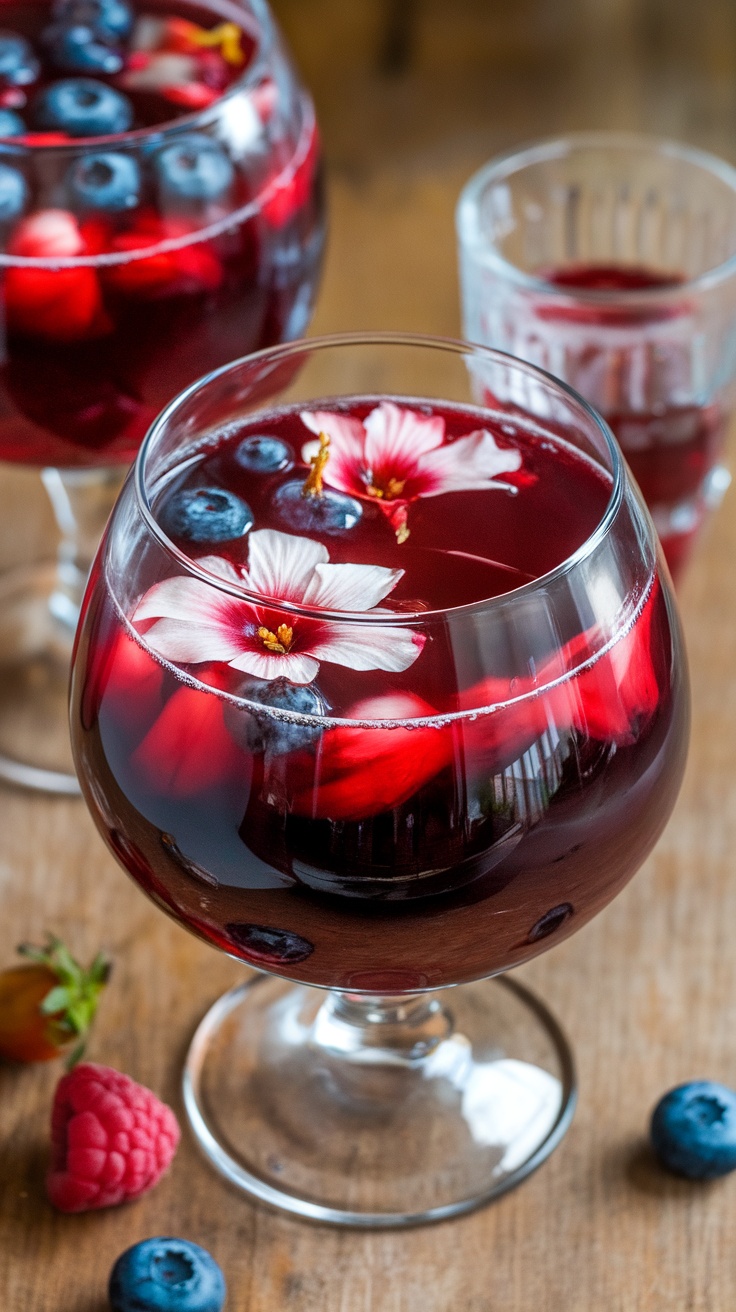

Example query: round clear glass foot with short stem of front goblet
[184,976,576,1228]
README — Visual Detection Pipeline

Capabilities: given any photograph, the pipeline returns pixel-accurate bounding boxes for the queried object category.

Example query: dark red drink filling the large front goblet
[72,403,687,992]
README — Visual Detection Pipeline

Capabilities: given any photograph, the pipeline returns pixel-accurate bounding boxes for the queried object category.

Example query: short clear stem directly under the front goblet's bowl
[311,991,454,1065]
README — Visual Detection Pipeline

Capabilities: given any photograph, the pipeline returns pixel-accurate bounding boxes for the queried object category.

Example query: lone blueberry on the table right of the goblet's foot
[649,1080,736,1179]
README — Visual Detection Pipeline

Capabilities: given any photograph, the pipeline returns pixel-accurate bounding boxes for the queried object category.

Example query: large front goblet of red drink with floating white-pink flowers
[71,335,689,1227]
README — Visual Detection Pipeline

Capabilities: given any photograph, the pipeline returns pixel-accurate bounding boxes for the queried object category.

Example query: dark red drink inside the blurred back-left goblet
[0,3,324,466]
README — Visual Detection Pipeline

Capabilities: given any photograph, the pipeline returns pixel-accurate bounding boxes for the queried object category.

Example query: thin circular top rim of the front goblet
[131,332,627,627]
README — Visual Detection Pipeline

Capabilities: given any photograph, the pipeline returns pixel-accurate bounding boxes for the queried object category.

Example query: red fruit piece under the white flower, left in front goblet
[133,687,241,798]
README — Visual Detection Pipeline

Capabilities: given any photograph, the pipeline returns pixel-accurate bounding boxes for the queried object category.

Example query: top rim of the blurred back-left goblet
[0,0,276,159]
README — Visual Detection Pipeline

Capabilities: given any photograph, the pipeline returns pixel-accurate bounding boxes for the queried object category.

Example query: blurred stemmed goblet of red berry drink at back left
[0,0,324,792]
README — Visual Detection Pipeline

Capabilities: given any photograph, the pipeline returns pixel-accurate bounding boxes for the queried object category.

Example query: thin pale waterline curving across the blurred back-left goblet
[0,91,316,270]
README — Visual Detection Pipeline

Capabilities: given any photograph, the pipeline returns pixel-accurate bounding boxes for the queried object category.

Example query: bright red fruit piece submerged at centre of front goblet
[288,693,453,820]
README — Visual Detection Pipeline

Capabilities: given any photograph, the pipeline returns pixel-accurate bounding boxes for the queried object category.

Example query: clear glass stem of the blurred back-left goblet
[41,466,126,630]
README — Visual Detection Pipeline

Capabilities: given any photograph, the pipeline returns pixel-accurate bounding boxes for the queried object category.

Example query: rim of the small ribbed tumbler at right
[455,129,736,307]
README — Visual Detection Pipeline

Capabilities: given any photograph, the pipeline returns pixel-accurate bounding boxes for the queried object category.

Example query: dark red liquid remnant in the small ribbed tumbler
[535,264,727,571]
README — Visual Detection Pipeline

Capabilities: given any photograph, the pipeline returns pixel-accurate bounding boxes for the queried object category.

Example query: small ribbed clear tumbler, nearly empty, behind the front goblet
[457,133,736,577]
